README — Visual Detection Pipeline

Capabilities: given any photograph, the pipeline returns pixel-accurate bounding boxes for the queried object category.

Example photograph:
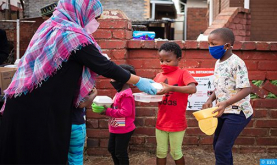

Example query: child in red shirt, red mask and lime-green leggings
[154,42,197,165]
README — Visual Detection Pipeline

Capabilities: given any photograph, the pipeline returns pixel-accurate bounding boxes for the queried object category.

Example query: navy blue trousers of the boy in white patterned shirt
[213,111,252,165]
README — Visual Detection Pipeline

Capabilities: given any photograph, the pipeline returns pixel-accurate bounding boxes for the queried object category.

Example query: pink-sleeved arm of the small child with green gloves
[105,97,133,117]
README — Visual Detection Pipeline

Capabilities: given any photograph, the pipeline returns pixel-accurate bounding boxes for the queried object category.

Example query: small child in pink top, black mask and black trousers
[93,64,136,165]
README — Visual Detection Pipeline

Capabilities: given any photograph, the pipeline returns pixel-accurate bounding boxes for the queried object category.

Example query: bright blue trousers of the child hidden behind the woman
[68,124,86,165]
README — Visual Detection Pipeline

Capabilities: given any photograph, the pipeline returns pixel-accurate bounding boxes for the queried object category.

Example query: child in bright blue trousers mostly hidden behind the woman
[68,88,97,165]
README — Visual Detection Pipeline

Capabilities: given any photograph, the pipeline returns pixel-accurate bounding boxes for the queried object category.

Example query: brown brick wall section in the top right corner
[250,0,277,41]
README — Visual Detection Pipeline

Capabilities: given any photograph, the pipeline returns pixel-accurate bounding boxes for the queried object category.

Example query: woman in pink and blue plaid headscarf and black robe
[0,0,156,164]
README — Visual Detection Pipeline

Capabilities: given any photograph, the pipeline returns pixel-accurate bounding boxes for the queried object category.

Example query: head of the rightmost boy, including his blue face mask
[208,28,235,59]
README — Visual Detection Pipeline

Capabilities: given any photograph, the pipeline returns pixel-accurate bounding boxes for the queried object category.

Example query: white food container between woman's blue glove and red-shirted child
[133,92,164,103]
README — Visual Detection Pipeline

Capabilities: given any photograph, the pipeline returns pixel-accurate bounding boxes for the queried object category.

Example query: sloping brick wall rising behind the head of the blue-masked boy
[204,7,251,41]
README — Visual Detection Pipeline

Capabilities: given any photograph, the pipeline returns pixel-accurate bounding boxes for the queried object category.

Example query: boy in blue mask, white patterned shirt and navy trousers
[203,28,253,165]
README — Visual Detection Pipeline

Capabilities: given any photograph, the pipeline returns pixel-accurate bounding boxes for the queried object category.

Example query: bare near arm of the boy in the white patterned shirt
[213,87,251,117]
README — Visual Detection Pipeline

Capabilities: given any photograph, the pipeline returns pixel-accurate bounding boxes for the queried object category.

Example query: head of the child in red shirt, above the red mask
[159,42,182,66]
